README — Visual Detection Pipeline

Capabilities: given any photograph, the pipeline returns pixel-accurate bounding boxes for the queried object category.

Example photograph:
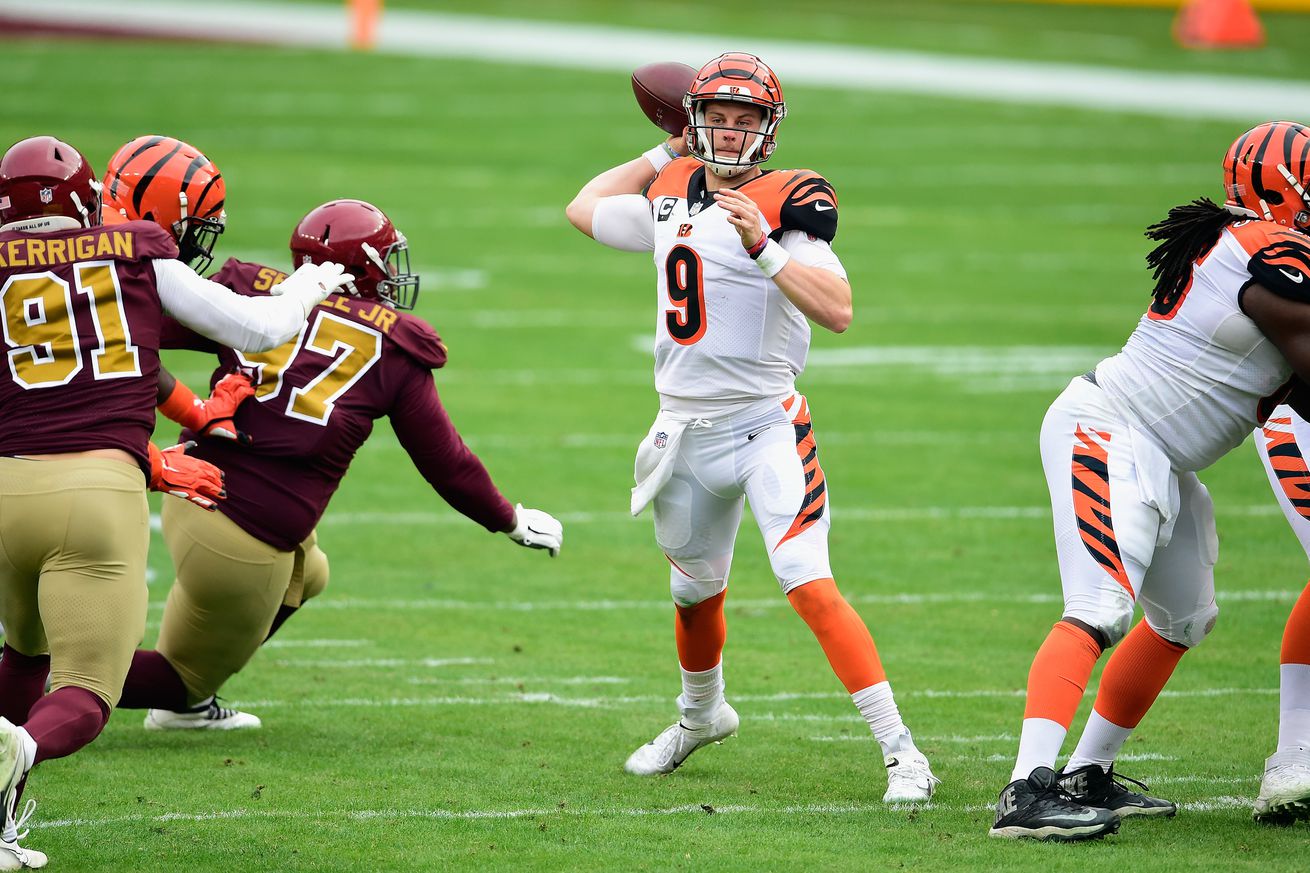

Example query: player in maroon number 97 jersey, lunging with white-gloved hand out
[119,199,563,729]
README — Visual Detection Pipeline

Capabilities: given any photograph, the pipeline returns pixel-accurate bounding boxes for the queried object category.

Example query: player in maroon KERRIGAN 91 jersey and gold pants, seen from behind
[0,136,346,869]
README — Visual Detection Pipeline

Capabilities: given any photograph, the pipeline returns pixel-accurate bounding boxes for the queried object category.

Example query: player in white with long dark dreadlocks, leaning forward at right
[990,122,1310,840]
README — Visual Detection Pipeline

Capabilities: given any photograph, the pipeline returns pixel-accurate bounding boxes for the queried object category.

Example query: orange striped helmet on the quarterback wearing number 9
[683,51,787,176]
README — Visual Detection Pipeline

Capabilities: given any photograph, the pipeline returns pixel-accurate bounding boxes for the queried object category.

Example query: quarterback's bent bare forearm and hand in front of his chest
[714,187,853,333]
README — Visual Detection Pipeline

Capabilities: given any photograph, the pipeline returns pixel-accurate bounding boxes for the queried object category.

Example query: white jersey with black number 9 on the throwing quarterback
[595,157,845,409]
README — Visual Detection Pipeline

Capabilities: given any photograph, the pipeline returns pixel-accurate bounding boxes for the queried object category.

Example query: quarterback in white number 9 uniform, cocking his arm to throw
[567,52,938,802]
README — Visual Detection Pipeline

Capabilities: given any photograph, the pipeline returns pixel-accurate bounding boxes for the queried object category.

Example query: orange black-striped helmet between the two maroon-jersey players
[105,136,228,273]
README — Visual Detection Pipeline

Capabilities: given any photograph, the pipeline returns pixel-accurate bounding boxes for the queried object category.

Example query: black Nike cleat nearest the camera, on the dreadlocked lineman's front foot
[988,767,1119,843]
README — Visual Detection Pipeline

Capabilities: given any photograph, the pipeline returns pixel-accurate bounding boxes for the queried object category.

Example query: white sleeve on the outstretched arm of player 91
[153,258,305,351]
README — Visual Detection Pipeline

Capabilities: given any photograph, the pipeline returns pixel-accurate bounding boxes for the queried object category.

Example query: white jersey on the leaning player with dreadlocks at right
[1095,222,1310,472]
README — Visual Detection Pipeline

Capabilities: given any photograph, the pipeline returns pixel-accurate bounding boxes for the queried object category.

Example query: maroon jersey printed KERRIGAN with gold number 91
[0,222,177,472]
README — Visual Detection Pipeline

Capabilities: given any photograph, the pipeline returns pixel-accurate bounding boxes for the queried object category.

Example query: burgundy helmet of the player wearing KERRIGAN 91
[0,136,100,229]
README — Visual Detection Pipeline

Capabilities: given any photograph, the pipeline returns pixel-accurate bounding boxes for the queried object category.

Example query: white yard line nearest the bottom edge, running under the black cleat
[30,796,1251,831]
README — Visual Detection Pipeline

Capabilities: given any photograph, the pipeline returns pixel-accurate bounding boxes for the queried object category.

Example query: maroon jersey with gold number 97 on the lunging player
[171,258,514,551]
